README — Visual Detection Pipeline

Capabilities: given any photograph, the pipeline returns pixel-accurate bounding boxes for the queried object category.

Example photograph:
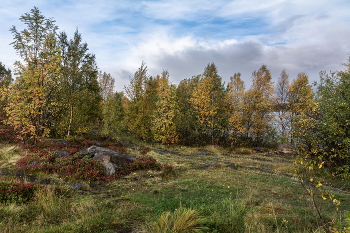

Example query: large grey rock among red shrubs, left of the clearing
[78,146,136,175]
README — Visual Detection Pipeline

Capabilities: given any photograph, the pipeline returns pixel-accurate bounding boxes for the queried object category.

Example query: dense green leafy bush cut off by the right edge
[313,72,350,178]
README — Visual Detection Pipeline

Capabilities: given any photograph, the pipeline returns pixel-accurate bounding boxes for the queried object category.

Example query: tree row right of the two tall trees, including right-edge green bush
[107,60,350,176]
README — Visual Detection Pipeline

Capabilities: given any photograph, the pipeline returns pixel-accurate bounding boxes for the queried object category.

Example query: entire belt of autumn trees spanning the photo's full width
[0,7,350,178]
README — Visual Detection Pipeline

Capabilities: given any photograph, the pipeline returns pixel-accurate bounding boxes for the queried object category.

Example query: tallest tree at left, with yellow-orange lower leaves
[5,7,60,142]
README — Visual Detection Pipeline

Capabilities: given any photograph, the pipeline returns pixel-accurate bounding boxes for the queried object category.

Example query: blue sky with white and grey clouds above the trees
[0,0,350,91]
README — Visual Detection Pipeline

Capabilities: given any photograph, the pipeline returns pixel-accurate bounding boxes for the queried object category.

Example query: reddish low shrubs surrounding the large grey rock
[16,138,172,181]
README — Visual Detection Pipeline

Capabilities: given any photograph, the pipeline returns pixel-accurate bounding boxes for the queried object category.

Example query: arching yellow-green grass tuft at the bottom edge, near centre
[148,207,207,233]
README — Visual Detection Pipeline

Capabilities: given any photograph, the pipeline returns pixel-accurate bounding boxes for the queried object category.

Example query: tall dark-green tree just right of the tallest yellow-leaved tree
[52,31,102,137]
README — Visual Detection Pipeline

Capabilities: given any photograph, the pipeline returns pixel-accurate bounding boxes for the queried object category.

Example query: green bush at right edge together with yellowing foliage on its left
[293,66,350,178]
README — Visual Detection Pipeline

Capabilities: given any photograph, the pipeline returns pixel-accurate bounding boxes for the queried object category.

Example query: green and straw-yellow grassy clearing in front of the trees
[0,136,350,233]
